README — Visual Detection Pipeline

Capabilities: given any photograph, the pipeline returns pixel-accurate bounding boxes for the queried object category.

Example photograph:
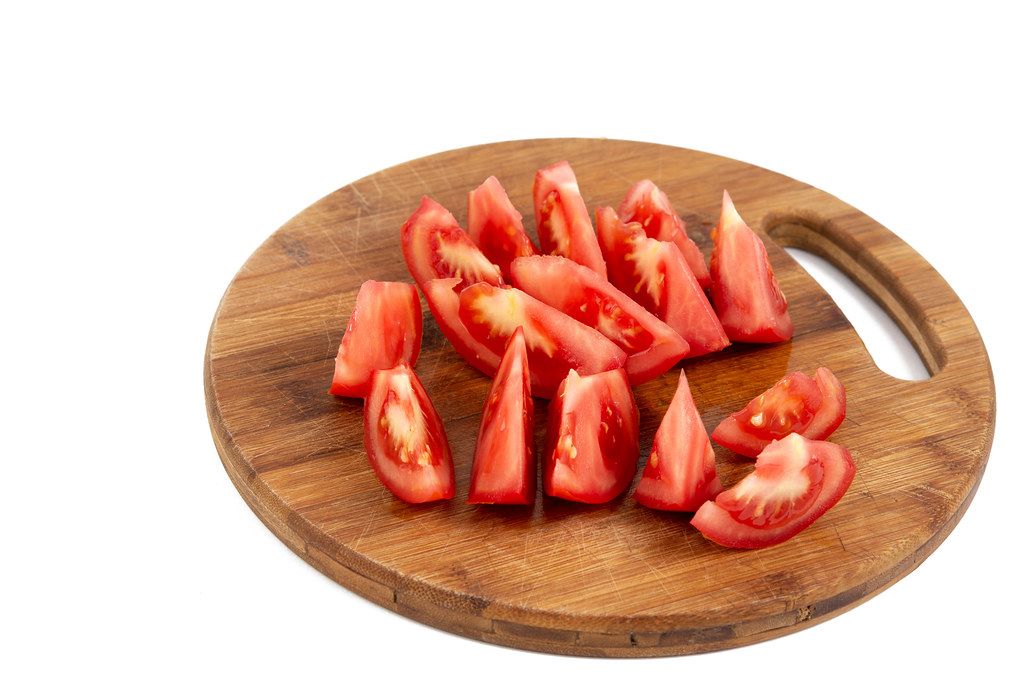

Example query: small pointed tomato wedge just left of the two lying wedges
[634,371,722,512]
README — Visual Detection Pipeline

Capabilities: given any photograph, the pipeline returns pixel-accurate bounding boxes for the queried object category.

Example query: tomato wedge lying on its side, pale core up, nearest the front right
[691,434,857,548]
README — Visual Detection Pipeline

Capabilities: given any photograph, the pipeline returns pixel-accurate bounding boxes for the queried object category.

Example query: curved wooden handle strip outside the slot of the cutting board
[760,202,991,381]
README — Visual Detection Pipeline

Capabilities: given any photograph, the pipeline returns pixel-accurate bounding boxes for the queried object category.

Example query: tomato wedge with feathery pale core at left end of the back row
[401,197,503,287]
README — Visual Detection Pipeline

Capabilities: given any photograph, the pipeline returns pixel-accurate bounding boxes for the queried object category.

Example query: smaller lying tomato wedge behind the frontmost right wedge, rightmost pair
[711,368,846,458]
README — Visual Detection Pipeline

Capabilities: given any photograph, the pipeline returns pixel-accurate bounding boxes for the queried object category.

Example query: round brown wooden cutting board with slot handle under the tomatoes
[206,139,995,656]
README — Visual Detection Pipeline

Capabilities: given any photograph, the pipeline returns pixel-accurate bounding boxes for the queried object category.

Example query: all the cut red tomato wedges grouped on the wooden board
[330,161,856,548]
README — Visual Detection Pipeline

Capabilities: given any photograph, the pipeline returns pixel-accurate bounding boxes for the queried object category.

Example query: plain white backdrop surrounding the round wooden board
[0,0,1024,681]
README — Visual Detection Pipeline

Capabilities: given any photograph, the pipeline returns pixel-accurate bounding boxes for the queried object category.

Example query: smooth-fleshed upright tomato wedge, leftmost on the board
[329,280,423,398]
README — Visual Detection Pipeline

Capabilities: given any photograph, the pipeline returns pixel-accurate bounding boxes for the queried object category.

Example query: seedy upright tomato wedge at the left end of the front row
[362,364,455,503]
